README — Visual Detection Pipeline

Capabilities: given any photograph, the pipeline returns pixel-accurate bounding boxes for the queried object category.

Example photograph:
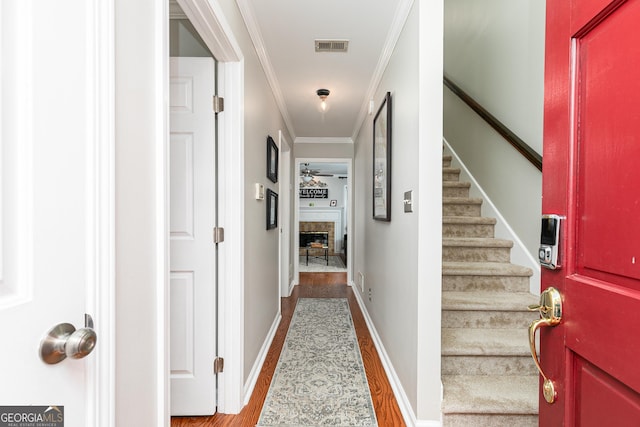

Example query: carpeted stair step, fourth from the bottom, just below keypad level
[442,262,533,292]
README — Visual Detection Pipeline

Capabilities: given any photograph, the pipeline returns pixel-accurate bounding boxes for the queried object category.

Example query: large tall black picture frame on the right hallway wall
[372,92,392,221]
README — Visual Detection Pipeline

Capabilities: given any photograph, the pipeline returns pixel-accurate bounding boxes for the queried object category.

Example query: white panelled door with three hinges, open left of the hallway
[170,58,217,415]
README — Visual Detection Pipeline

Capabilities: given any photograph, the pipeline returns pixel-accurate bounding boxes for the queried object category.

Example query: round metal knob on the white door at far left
[40,315,97,365]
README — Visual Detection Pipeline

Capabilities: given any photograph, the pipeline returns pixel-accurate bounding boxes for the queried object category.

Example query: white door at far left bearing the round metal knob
[0,0,113,427]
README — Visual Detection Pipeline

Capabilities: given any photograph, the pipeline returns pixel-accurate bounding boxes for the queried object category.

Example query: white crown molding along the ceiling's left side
[236,0,296,141]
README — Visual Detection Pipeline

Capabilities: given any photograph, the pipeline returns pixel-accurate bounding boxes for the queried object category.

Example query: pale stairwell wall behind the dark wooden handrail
[444,0,545,267]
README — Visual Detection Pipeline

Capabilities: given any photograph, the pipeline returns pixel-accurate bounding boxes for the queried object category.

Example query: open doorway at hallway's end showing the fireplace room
[292,158,353,283]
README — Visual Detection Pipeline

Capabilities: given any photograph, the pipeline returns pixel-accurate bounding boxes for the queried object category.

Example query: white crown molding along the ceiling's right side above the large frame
[351,0,414,141]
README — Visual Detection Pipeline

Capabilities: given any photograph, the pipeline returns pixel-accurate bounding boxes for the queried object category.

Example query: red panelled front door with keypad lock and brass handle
[540,0,640,427]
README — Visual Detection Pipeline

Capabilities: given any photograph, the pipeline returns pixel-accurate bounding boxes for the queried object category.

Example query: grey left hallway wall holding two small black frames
[219,0,292,381]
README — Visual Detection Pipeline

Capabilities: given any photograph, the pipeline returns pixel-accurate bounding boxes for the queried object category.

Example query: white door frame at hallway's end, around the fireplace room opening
[293,157,353,284]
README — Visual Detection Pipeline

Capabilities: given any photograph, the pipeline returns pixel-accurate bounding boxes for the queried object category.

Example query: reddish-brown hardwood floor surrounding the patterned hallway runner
[171,273,405,427]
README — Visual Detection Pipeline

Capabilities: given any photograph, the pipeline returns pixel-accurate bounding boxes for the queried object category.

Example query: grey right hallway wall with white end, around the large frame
[354,1,442,425]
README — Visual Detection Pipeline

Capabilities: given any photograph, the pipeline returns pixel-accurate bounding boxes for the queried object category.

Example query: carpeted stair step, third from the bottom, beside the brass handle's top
[442,291,539,330]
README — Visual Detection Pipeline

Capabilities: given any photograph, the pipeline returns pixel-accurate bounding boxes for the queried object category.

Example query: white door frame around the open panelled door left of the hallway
[174,0,244,414]
